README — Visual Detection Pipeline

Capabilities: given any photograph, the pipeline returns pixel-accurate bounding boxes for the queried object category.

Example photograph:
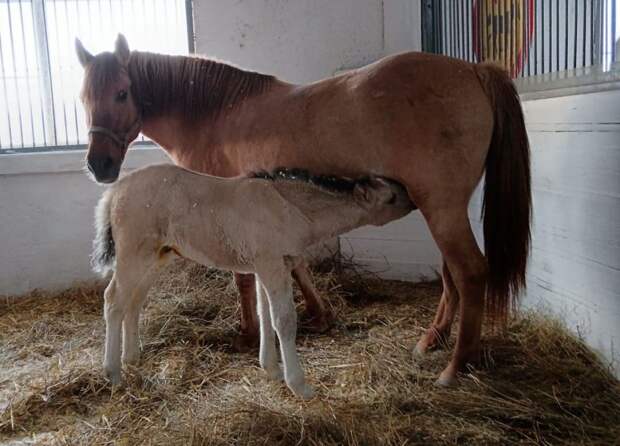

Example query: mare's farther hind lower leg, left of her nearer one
[414,261,459,355]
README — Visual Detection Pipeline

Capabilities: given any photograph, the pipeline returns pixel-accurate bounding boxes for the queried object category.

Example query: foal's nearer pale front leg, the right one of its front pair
[258,261,314,399]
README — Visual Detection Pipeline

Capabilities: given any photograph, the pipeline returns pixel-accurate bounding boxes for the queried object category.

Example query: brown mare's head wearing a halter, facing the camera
[75,34,141,183]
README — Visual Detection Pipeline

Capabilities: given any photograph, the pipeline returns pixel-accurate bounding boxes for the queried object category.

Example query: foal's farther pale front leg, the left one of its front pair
[256,276,282,381]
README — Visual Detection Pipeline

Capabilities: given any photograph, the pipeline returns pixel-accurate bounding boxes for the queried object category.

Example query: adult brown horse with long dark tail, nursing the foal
[77,36,531,385]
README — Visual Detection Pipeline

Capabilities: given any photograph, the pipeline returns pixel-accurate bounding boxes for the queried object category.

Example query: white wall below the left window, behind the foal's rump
[0,148,167,295]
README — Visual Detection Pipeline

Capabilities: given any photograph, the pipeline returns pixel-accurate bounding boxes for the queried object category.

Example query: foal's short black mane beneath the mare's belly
[249,167,370,193]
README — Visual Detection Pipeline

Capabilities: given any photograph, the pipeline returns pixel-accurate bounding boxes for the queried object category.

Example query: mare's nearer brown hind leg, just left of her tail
[424,207,487,386]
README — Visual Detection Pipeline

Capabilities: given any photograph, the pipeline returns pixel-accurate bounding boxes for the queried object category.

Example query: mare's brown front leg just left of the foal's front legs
[233,273,260,351]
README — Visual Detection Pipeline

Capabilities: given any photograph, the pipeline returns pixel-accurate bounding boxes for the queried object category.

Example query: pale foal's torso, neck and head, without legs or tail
[110,164,411,272]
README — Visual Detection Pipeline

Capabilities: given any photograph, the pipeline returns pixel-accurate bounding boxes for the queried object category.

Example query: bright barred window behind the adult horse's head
[0,0,193,153]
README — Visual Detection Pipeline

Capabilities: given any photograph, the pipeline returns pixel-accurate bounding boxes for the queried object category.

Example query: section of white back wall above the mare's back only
[194,0,419,83]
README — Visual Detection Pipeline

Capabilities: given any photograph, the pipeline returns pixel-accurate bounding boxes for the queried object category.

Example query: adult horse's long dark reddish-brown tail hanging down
[476,65,532,322]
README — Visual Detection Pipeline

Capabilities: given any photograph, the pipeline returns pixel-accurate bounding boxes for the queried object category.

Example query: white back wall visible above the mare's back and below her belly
[194,0,440,279]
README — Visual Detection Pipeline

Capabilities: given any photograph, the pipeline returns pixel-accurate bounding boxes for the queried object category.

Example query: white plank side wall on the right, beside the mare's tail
[471,90,620,375]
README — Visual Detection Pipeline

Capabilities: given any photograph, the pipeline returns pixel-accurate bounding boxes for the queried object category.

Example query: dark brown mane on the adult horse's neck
[128,51,275,119]
